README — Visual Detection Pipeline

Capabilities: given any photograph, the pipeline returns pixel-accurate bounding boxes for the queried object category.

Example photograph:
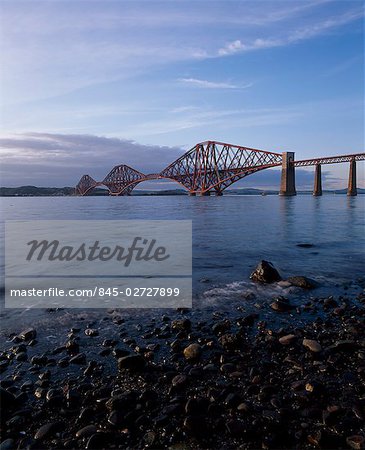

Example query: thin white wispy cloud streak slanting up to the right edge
[217,9,364,56]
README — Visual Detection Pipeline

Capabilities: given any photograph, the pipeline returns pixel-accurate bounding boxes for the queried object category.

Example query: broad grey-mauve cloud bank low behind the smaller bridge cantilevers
[0,133,184,186]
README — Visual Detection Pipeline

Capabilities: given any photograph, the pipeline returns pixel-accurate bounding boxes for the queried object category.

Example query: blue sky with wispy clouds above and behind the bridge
[0,0,365,189]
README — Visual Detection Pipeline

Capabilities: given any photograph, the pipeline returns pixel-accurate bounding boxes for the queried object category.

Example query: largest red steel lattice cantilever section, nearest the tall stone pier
[161,141,282,192]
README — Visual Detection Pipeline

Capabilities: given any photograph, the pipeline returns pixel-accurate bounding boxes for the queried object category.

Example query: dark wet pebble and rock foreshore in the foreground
[0,278,365,450]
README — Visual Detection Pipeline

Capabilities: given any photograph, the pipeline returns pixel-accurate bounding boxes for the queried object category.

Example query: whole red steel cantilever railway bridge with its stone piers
[76,141,365,196]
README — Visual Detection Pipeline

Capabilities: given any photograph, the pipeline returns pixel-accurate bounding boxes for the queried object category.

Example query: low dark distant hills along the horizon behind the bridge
[0,186,365,197]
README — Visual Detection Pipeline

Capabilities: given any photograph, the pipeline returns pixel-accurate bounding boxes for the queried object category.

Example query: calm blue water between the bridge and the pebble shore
[1,195,365,332]
